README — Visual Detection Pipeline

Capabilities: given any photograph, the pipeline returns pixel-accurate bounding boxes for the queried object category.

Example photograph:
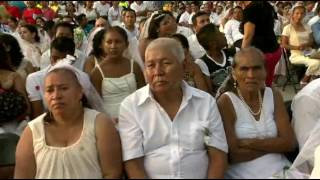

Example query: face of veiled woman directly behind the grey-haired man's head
[159,15,177,37]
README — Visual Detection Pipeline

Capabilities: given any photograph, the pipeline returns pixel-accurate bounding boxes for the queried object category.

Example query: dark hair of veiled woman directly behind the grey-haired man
[148,11,174,39]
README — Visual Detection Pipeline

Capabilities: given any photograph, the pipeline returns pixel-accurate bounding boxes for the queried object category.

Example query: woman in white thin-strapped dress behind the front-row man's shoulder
[90,26,145,119]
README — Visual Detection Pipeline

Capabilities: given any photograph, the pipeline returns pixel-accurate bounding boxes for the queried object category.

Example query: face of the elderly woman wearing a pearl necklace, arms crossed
[232,53,267,91]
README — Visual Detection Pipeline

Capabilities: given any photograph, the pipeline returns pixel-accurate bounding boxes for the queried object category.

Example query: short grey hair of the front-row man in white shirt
[145,37,185,64]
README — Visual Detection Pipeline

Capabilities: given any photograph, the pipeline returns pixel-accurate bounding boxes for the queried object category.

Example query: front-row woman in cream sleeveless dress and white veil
[14,61,122,179]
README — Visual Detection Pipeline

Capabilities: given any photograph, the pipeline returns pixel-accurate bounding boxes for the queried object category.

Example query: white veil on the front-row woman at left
[48,55,107,114]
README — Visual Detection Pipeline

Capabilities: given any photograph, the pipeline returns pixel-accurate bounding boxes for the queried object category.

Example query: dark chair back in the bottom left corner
[0,133,19,179]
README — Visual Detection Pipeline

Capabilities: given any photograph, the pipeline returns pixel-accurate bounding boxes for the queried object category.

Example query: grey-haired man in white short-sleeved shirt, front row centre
[119,38,228,179]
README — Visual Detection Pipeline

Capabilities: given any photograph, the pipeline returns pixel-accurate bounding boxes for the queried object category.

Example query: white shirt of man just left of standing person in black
[224,19,243,45]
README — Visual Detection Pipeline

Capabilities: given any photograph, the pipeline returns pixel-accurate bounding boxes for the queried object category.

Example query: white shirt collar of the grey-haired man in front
[138,81,204,106]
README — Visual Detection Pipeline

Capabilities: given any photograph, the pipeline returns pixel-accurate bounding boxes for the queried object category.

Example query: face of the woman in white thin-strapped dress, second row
[102,31,127,58]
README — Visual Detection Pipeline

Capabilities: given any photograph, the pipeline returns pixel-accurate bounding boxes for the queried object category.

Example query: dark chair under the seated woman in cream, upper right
[282,48,306,93]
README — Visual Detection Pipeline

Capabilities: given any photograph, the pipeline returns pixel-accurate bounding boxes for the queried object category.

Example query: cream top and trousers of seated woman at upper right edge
[282,24,320,76]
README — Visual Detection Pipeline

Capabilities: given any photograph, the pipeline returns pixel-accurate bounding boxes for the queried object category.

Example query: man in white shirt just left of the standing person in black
[224,6,243,48]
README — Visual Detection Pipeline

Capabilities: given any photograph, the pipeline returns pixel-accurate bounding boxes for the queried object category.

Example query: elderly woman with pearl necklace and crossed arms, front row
[217,47,296,179]
